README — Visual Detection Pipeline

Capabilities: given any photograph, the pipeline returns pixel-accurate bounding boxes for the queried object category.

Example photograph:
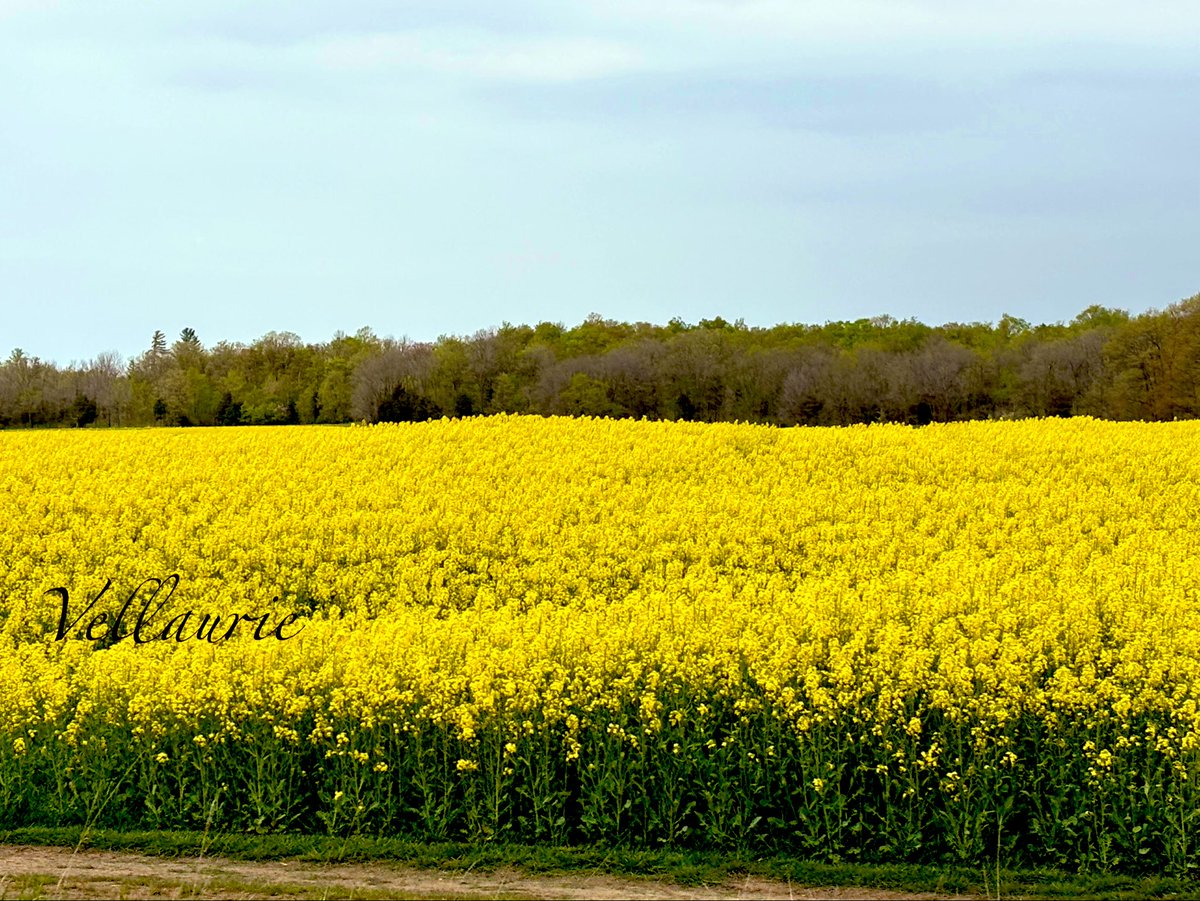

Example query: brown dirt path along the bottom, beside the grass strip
[0,846,969,901]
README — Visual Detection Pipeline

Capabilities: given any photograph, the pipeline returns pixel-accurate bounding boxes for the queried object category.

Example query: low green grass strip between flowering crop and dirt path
[0,827,1200,900]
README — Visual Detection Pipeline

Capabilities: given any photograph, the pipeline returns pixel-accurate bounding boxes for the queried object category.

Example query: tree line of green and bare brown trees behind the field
[0,294,1200,427]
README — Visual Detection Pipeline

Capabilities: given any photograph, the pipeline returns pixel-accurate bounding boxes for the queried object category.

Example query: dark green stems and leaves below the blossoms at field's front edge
[0,700,1200,878]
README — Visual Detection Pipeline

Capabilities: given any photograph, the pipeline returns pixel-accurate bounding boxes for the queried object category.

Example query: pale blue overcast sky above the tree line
[0,0,1200,364]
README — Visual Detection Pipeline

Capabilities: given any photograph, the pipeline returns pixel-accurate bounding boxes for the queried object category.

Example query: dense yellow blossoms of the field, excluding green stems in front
[0,416,1200,863]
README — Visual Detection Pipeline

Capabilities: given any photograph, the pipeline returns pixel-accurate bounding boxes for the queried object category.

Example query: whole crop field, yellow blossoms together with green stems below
[0,416,1200,872]
